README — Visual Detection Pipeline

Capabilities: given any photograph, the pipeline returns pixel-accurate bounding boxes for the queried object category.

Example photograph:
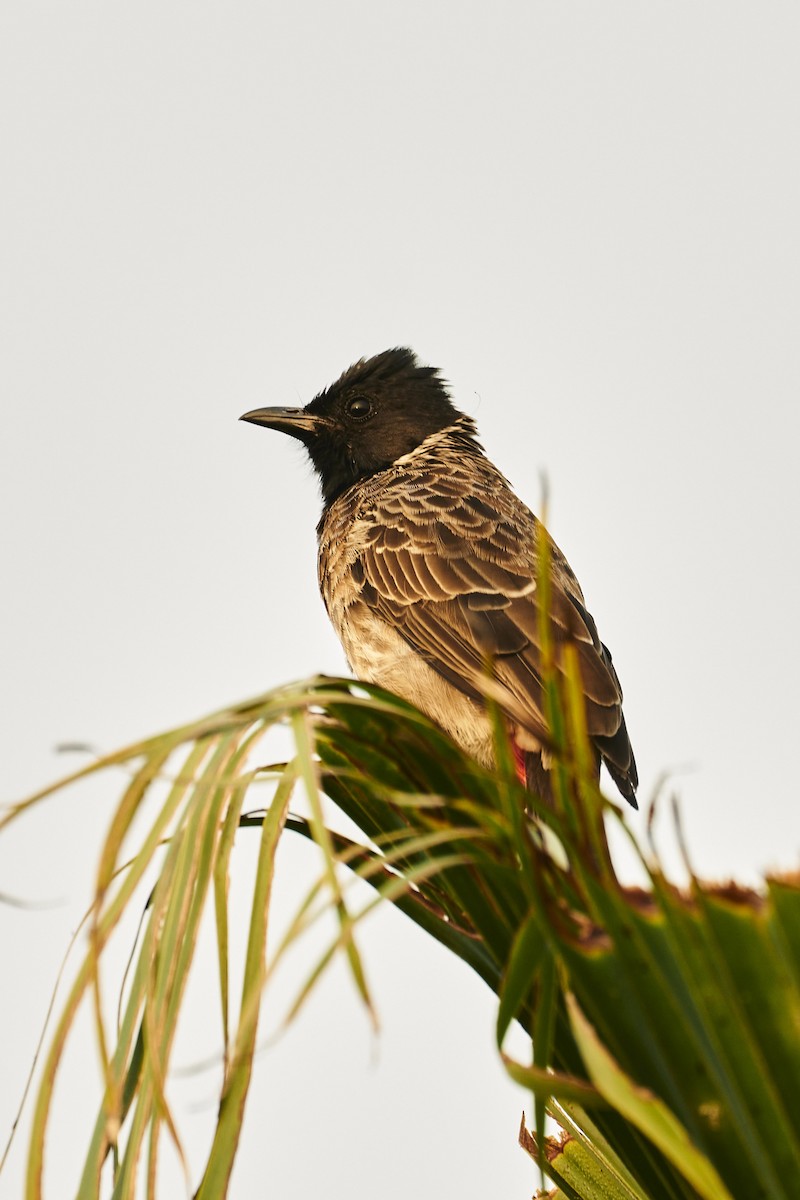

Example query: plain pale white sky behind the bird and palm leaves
[0,0,800,1200]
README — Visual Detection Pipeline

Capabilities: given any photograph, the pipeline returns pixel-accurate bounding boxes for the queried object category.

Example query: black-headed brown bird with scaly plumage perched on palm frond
[240,347,638,808]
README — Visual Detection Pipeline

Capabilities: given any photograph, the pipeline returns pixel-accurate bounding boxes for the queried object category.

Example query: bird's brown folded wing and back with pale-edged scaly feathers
[356,478,637,799]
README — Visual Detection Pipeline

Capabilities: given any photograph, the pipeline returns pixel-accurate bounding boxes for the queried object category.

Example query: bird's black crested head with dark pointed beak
[241,347,462,505]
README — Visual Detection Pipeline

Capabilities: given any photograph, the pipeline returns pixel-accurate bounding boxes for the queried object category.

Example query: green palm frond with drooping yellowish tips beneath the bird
[0,681,800,1200]
